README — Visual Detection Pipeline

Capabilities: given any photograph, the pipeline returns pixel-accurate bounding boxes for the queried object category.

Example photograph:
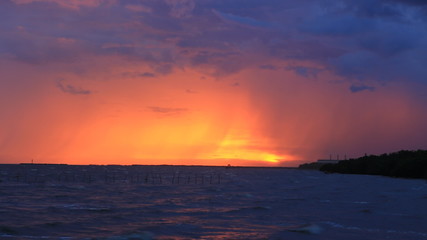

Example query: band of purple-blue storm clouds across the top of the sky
[0,0,427,85]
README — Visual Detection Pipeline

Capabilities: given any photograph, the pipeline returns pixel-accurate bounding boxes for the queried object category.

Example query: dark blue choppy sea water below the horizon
[0,164,427,240]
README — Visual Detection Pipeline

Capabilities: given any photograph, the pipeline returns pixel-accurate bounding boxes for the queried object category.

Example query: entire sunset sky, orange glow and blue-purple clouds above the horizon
[0,0,427,166]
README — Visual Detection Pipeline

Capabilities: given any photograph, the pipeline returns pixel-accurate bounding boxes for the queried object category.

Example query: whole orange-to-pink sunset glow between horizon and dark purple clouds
[0,59,426,166]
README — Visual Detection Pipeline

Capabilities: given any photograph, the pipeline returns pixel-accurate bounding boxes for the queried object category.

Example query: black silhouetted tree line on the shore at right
[320,150,427,179]
